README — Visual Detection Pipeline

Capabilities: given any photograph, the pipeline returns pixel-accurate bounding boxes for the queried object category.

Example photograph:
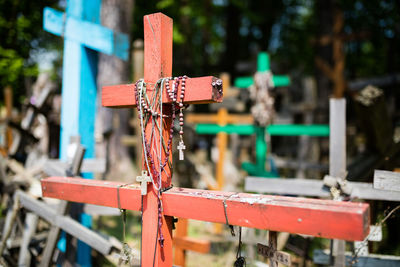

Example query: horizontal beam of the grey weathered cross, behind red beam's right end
[244,176,400,201]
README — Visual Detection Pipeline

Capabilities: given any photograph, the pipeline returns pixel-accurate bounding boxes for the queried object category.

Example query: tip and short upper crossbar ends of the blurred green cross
[234,52,290,89]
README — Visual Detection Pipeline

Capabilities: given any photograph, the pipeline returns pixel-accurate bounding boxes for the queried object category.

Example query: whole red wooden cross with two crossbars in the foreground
[42,13,369,266]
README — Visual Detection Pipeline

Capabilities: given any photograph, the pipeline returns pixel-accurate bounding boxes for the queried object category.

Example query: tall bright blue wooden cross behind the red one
[43,0,129,266]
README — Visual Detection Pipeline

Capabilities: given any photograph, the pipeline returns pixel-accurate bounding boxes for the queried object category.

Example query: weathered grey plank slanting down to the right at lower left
[16,192,114,255]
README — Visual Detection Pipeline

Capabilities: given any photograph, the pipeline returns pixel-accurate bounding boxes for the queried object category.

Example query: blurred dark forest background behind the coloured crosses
[0,0,400,266]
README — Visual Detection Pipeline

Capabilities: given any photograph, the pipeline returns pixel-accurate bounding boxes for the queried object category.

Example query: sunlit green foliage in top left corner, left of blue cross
[0,0,58,107]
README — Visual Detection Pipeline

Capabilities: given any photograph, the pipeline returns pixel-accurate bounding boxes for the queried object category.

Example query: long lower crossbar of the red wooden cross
[41,177,369,241]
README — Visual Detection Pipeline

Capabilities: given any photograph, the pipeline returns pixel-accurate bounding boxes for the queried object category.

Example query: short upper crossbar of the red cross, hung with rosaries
[102,76,222,107]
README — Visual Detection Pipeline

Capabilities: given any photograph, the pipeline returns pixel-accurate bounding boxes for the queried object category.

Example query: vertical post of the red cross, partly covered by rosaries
[141,13,172,266]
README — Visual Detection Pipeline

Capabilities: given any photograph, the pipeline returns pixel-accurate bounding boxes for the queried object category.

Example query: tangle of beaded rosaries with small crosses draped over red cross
[135,75,188,253]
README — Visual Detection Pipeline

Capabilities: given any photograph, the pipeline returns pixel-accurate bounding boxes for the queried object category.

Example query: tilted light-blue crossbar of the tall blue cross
[43,7,129,60]
